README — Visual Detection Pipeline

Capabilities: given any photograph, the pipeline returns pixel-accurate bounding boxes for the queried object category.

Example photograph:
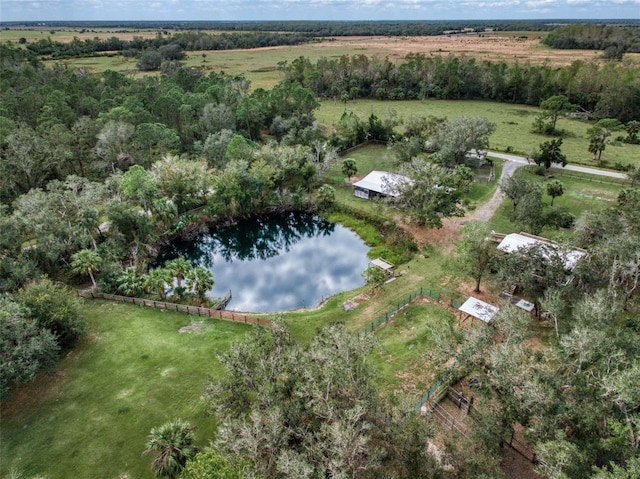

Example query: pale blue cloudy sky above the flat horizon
[0,0,640,22]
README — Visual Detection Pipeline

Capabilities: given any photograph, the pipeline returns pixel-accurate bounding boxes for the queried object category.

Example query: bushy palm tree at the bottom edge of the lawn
[143,419,198,479]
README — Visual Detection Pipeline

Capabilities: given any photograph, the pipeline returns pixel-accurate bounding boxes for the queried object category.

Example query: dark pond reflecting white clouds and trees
[158,213,369,313]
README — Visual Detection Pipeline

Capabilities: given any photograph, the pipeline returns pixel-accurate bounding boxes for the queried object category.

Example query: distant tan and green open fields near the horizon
[30,29,640,88]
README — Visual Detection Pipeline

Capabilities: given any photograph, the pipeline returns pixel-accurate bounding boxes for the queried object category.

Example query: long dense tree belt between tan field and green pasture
[281,53,640,122]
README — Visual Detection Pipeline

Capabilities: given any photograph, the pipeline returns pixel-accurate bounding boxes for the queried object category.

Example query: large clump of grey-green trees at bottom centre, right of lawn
[207,325,442,479]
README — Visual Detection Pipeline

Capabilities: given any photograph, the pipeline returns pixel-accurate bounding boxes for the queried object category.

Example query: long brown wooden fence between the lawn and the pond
[78,291,271,326]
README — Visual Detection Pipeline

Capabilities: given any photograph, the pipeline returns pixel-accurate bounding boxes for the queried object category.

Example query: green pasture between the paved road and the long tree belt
[316,100,640,166]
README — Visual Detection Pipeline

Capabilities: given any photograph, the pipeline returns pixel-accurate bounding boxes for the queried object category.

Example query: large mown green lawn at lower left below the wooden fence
[0,301,248,479]
